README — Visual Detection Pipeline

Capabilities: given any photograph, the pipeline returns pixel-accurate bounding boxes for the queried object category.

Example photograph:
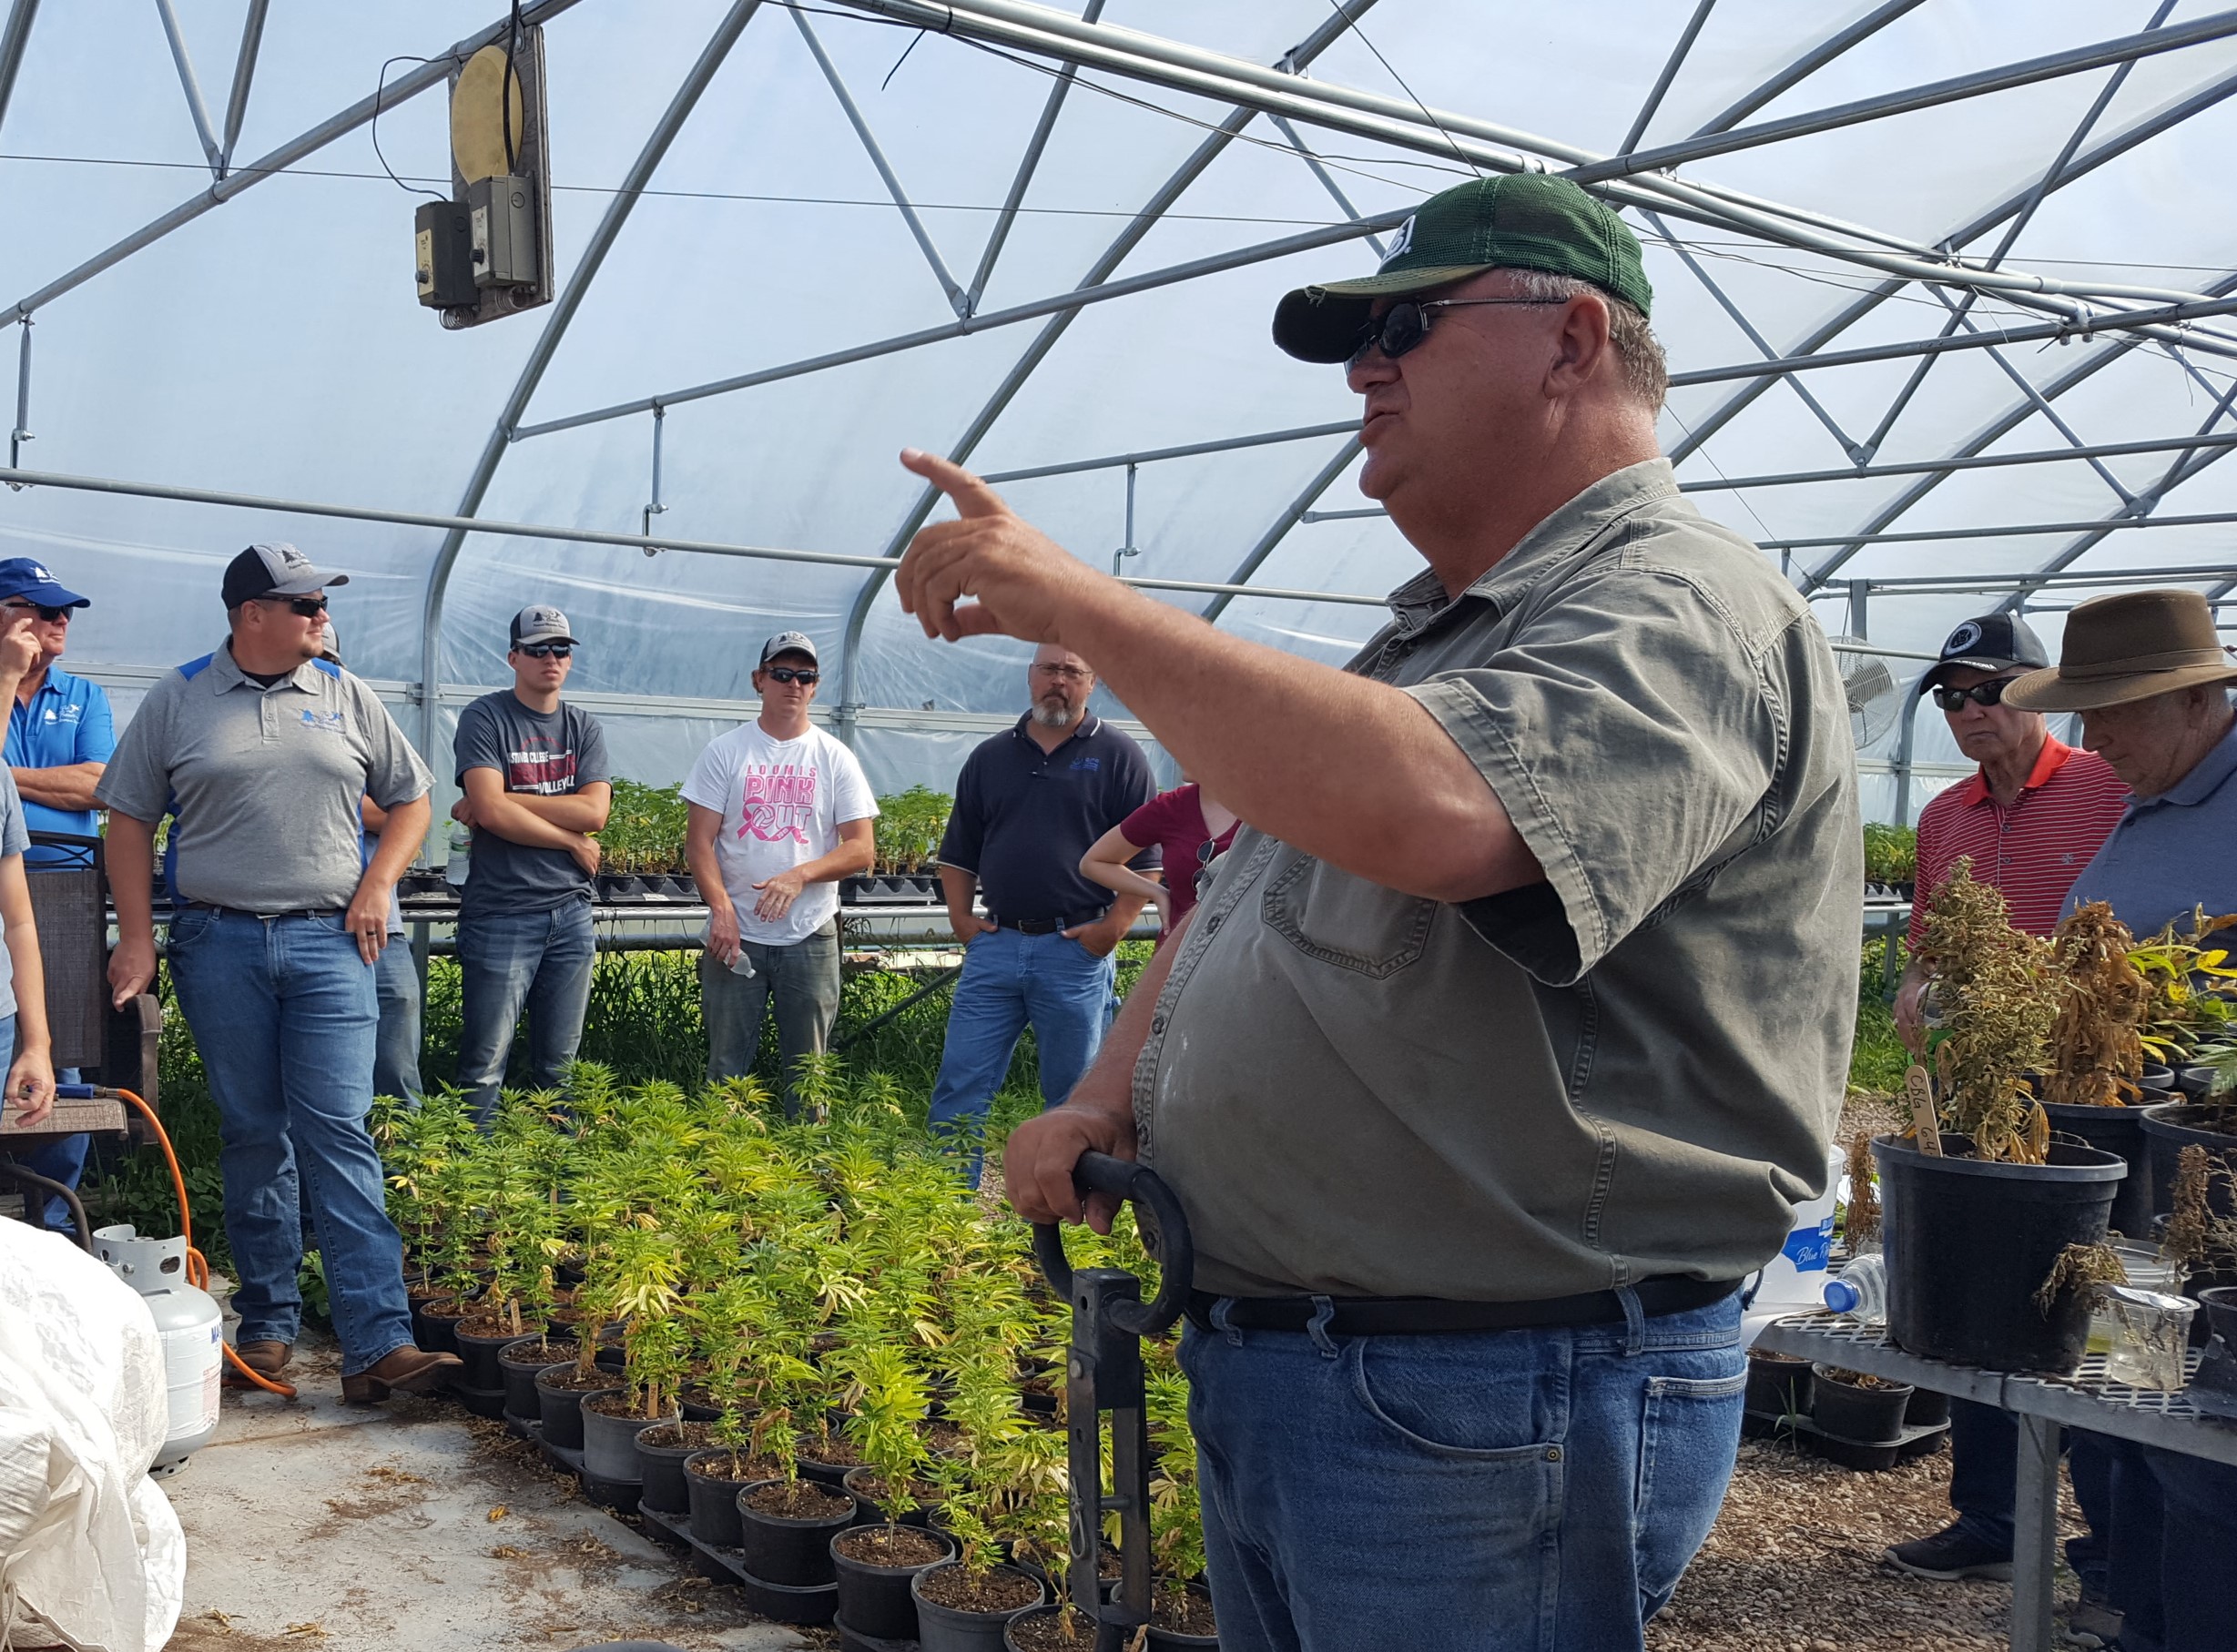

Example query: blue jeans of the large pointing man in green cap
[1181,1296,1747,1652]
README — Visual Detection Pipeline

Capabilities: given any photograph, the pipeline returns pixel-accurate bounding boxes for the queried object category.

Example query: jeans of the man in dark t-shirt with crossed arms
[459,901,597,1124]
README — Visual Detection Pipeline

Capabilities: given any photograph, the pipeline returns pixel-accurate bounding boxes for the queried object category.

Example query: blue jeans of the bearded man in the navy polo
[930,930,1119,1187]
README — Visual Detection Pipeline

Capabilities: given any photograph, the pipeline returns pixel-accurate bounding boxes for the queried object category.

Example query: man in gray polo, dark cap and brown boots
[97,545,459,1404]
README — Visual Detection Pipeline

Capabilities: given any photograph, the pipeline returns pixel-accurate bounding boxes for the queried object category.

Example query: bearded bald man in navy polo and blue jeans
[930,644,1159,1182]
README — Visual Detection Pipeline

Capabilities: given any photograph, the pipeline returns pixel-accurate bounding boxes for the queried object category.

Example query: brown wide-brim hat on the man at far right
[2004,590,2237,711]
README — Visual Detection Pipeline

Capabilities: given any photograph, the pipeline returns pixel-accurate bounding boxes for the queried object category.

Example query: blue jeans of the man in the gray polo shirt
[170,910,412,1374]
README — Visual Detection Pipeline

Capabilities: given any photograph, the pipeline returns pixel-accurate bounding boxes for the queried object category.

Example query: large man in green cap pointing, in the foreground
[900,177,1864,1652]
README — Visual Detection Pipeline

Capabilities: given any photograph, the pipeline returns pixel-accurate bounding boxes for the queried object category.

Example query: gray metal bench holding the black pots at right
[1754,1312,2237,1652]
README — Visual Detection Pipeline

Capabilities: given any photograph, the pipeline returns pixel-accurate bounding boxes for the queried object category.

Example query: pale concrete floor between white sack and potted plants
[161,1342,830,1652]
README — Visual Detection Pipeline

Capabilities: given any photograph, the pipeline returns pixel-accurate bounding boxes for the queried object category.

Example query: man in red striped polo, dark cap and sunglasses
[1888,613,2128,1621]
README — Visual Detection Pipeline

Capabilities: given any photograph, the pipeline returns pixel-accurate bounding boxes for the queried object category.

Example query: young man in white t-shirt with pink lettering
[685,631,877,1116]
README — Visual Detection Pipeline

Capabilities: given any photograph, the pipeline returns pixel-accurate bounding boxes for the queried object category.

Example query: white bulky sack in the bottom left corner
[0,1221,186,1652]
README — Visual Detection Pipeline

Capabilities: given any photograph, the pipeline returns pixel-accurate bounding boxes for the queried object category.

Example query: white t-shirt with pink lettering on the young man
[685,722,877,946]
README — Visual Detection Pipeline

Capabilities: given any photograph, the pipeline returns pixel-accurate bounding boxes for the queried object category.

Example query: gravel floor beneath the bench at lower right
[1646,1440,2080,1652]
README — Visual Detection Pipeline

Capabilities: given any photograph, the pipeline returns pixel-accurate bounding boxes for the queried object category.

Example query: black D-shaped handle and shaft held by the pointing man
[1033,1153,1196,1652]
